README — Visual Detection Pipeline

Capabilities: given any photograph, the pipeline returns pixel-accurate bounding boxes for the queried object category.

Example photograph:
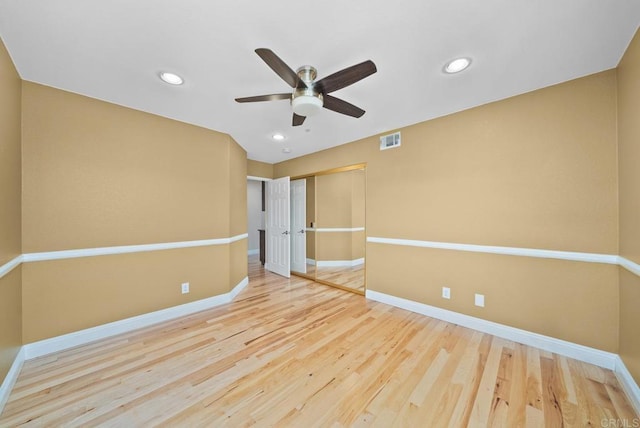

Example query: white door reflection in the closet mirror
[291,179,307,273]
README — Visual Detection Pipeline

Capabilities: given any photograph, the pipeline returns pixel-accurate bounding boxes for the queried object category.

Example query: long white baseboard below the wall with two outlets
[365,290,620,370]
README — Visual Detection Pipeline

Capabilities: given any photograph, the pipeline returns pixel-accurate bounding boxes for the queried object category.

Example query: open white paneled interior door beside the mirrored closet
[264,177,291,278]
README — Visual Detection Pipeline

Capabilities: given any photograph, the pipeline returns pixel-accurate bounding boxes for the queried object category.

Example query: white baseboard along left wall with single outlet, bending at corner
[23,277,249,360]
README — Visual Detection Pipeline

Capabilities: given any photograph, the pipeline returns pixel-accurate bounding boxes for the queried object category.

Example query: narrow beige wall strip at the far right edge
[618,26,640,383]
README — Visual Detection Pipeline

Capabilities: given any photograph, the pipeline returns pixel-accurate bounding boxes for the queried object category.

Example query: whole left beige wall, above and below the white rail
[22,82,247,342]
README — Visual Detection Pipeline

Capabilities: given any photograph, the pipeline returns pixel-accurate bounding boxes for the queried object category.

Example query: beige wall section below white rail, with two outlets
[367,243,618,352]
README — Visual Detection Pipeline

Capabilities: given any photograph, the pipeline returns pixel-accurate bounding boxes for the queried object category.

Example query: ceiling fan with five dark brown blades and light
[236,48,377,126]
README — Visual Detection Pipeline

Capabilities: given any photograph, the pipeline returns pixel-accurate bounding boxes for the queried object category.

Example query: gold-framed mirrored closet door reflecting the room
[291,164,366,294]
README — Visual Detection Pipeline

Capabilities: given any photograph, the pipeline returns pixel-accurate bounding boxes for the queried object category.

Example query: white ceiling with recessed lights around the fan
[0,0,640,163]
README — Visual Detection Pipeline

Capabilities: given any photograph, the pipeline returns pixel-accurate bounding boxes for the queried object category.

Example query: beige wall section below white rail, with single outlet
[22,245,230,343]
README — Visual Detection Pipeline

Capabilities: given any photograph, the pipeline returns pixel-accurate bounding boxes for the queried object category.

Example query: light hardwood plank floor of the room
[0,259,638,427]
